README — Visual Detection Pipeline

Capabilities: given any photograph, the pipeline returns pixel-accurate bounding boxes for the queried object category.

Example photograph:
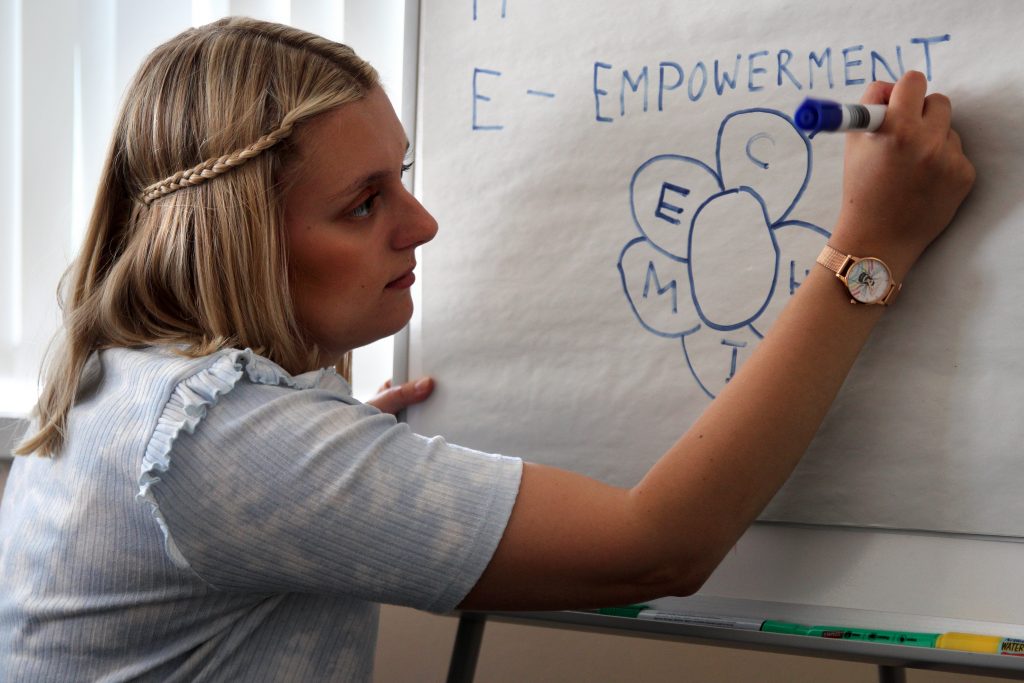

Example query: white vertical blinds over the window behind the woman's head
[0,0,407,416]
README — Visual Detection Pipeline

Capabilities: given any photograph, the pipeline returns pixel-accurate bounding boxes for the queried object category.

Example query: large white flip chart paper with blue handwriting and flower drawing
[410,0,1024,537]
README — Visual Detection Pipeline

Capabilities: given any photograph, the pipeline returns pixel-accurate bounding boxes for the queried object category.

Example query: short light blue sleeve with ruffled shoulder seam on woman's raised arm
[141,354,522,611]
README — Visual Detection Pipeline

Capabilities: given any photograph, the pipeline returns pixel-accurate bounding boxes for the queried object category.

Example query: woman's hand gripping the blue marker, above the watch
[829,71,975,282]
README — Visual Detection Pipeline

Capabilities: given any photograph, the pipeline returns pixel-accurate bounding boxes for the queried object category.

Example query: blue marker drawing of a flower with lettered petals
[618,109,828,398]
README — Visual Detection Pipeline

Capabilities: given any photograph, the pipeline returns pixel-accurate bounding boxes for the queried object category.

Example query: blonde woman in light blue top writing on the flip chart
[0,14,974,681]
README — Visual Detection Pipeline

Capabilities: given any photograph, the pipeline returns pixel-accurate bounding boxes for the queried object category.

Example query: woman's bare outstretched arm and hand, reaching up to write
[460,72,974,609]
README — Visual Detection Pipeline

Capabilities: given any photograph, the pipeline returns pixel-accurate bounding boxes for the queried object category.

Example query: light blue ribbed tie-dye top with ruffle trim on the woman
[0,348,522,682]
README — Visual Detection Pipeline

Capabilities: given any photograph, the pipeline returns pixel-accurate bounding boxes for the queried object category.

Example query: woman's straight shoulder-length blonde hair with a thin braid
[16,17,379,455]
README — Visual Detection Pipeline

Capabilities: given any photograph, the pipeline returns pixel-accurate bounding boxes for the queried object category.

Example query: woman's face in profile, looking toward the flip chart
[284,88,437,364]
